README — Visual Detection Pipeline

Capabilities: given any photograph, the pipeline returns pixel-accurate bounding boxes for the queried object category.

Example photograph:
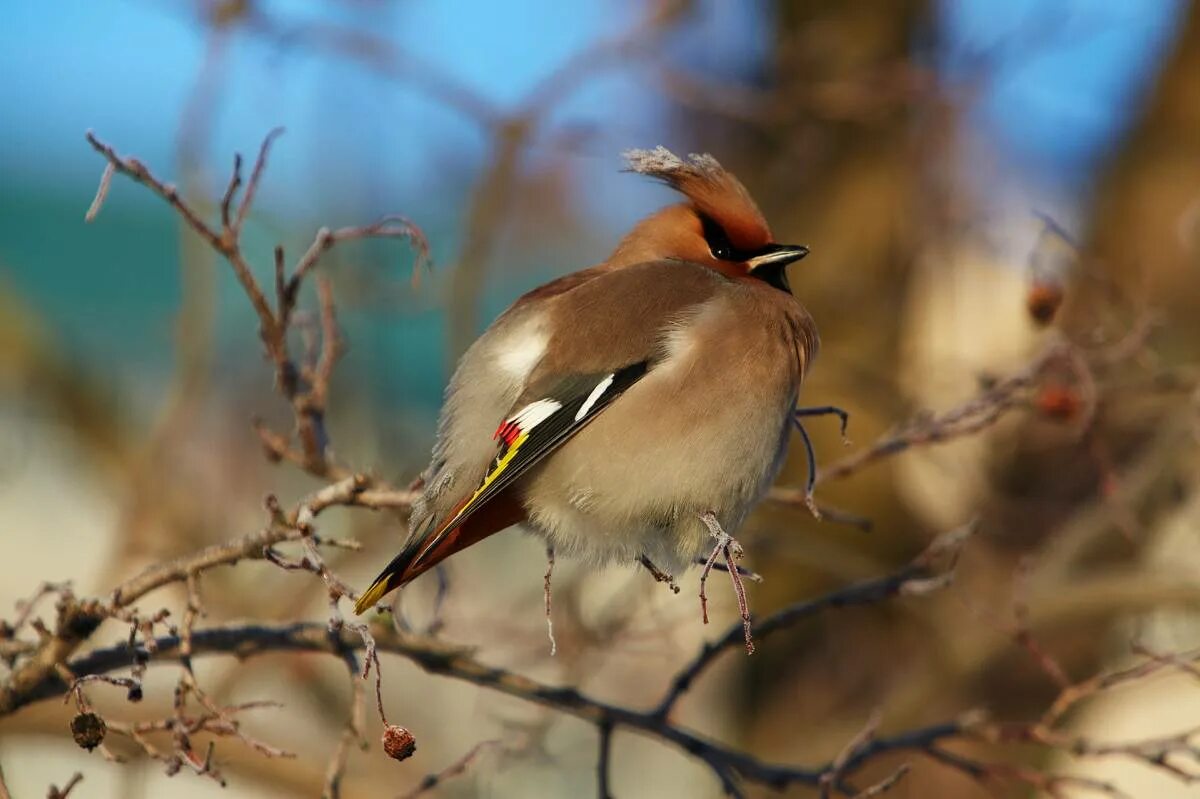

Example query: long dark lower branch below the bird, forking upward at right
[9,547,1200,795]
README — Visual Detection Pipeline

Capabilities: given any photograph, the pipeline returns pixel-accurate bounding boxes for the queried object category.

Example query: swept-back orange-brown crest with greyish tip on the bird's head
[624,144,772,251]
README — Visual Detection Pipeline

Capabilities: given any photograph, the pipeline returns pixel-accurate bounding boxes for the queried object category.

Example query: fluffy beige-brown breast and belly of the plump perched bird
[524,291,799,554]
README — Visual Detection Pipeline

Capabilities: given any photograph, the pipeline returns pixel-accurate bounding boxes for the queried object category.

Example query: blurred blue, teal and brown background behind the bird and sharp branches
[0,0,1200,798]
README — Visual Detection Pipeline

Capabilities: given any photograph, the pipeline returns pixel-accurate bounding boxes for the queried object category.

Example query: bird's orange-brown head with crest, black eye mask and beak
[608,146,809,292]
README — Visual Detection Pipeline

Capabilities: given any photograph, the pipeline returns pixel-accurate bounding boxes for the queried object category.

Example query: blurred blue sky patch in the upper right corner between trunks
[941,0,1182,184]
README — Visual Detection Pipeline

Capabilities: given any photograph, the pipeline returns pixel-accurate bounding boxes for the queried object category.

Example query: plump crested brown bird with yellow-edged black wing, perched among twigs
[355,145,820,614]
